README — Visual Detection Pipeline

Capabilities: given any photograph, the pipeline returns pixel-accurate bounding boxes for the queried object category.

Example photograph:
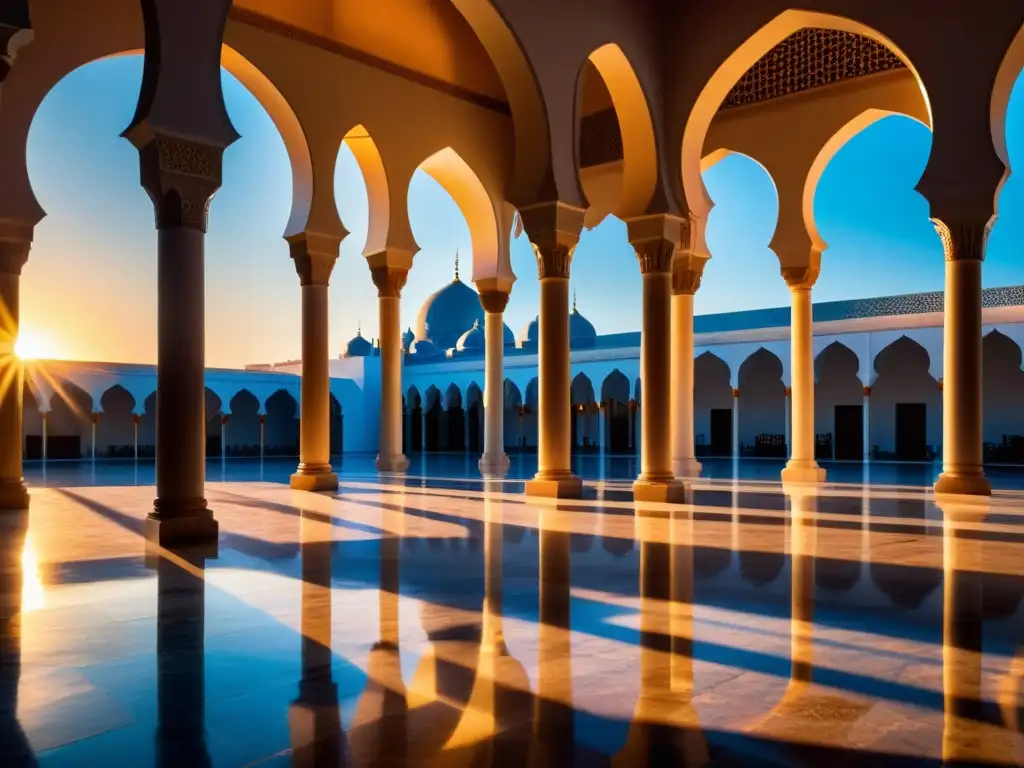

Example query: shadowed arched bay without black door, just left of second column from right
[738,347,786,459]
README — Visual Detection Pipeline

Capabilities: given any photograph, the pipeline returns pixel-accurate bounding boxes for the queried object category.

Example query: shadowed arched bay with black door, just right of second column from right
[814,341,864,461]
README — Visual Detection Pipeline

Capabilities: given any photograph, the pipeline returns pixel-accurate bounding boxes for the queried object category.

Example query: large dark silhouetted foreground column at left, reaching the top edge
[122,0,239,546]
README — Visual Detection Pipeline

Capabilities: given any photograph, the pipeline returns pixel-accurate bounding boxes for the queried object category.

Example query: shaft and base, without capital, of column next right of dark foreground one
[291,281,338,490]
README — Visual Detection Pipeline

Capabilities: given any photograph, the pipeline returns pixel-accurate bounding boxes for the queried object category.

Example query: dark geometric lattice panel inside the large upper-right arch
[720,29,904,110]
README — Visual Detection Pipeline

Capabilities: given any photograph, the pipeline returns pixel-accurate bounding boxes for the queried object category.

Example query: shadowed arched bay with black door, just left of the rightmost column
[870,336,942,461]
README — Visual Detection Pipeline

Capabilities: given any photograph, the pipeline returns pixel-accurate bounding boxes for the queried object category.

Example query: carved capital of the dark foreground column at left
[139,134,224,232]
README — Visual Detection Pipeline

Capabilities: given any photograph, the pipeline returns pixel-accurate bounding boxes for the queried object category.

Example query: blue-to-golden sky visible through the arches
[22,56,1024,367]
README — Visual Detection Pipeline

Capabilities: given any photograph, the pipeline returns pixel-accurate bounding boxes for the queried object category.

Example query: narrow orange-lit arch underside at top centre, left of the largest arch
[575,43,657,226]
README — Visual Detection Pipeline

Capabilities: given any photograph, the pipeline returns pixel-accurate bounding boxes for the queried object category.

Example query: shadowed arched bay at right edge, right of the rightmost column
[981,331,1024,464]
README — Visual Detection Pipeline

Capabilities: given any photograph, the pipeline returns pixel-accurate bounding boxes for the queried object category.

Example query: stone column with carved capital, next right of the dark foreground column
[286,232,341,490]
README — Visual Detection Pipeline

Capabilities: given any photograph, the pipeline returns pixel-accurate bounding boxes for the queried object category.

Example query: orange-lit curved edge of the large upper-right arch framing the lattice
[680,8,932,222]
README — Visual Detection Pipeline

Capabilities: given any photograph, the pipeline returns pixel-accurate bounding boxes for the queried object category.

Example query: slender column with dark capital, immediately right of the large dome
[479,290,509,475]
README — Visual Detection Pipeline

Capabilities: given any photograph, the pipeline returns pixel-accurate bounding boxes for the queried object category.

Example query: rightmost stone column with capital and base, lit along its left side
[935,219,992,496]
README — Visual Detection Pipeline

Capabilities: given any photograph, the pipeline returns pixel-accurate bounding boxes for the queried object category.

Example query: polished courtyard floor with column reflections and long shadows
[0,475,1024,767]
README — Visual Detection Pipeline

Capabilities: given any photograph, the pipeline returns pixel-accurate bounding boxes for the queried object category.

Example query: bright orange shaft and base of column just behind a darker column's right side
[672,292,700,477]
